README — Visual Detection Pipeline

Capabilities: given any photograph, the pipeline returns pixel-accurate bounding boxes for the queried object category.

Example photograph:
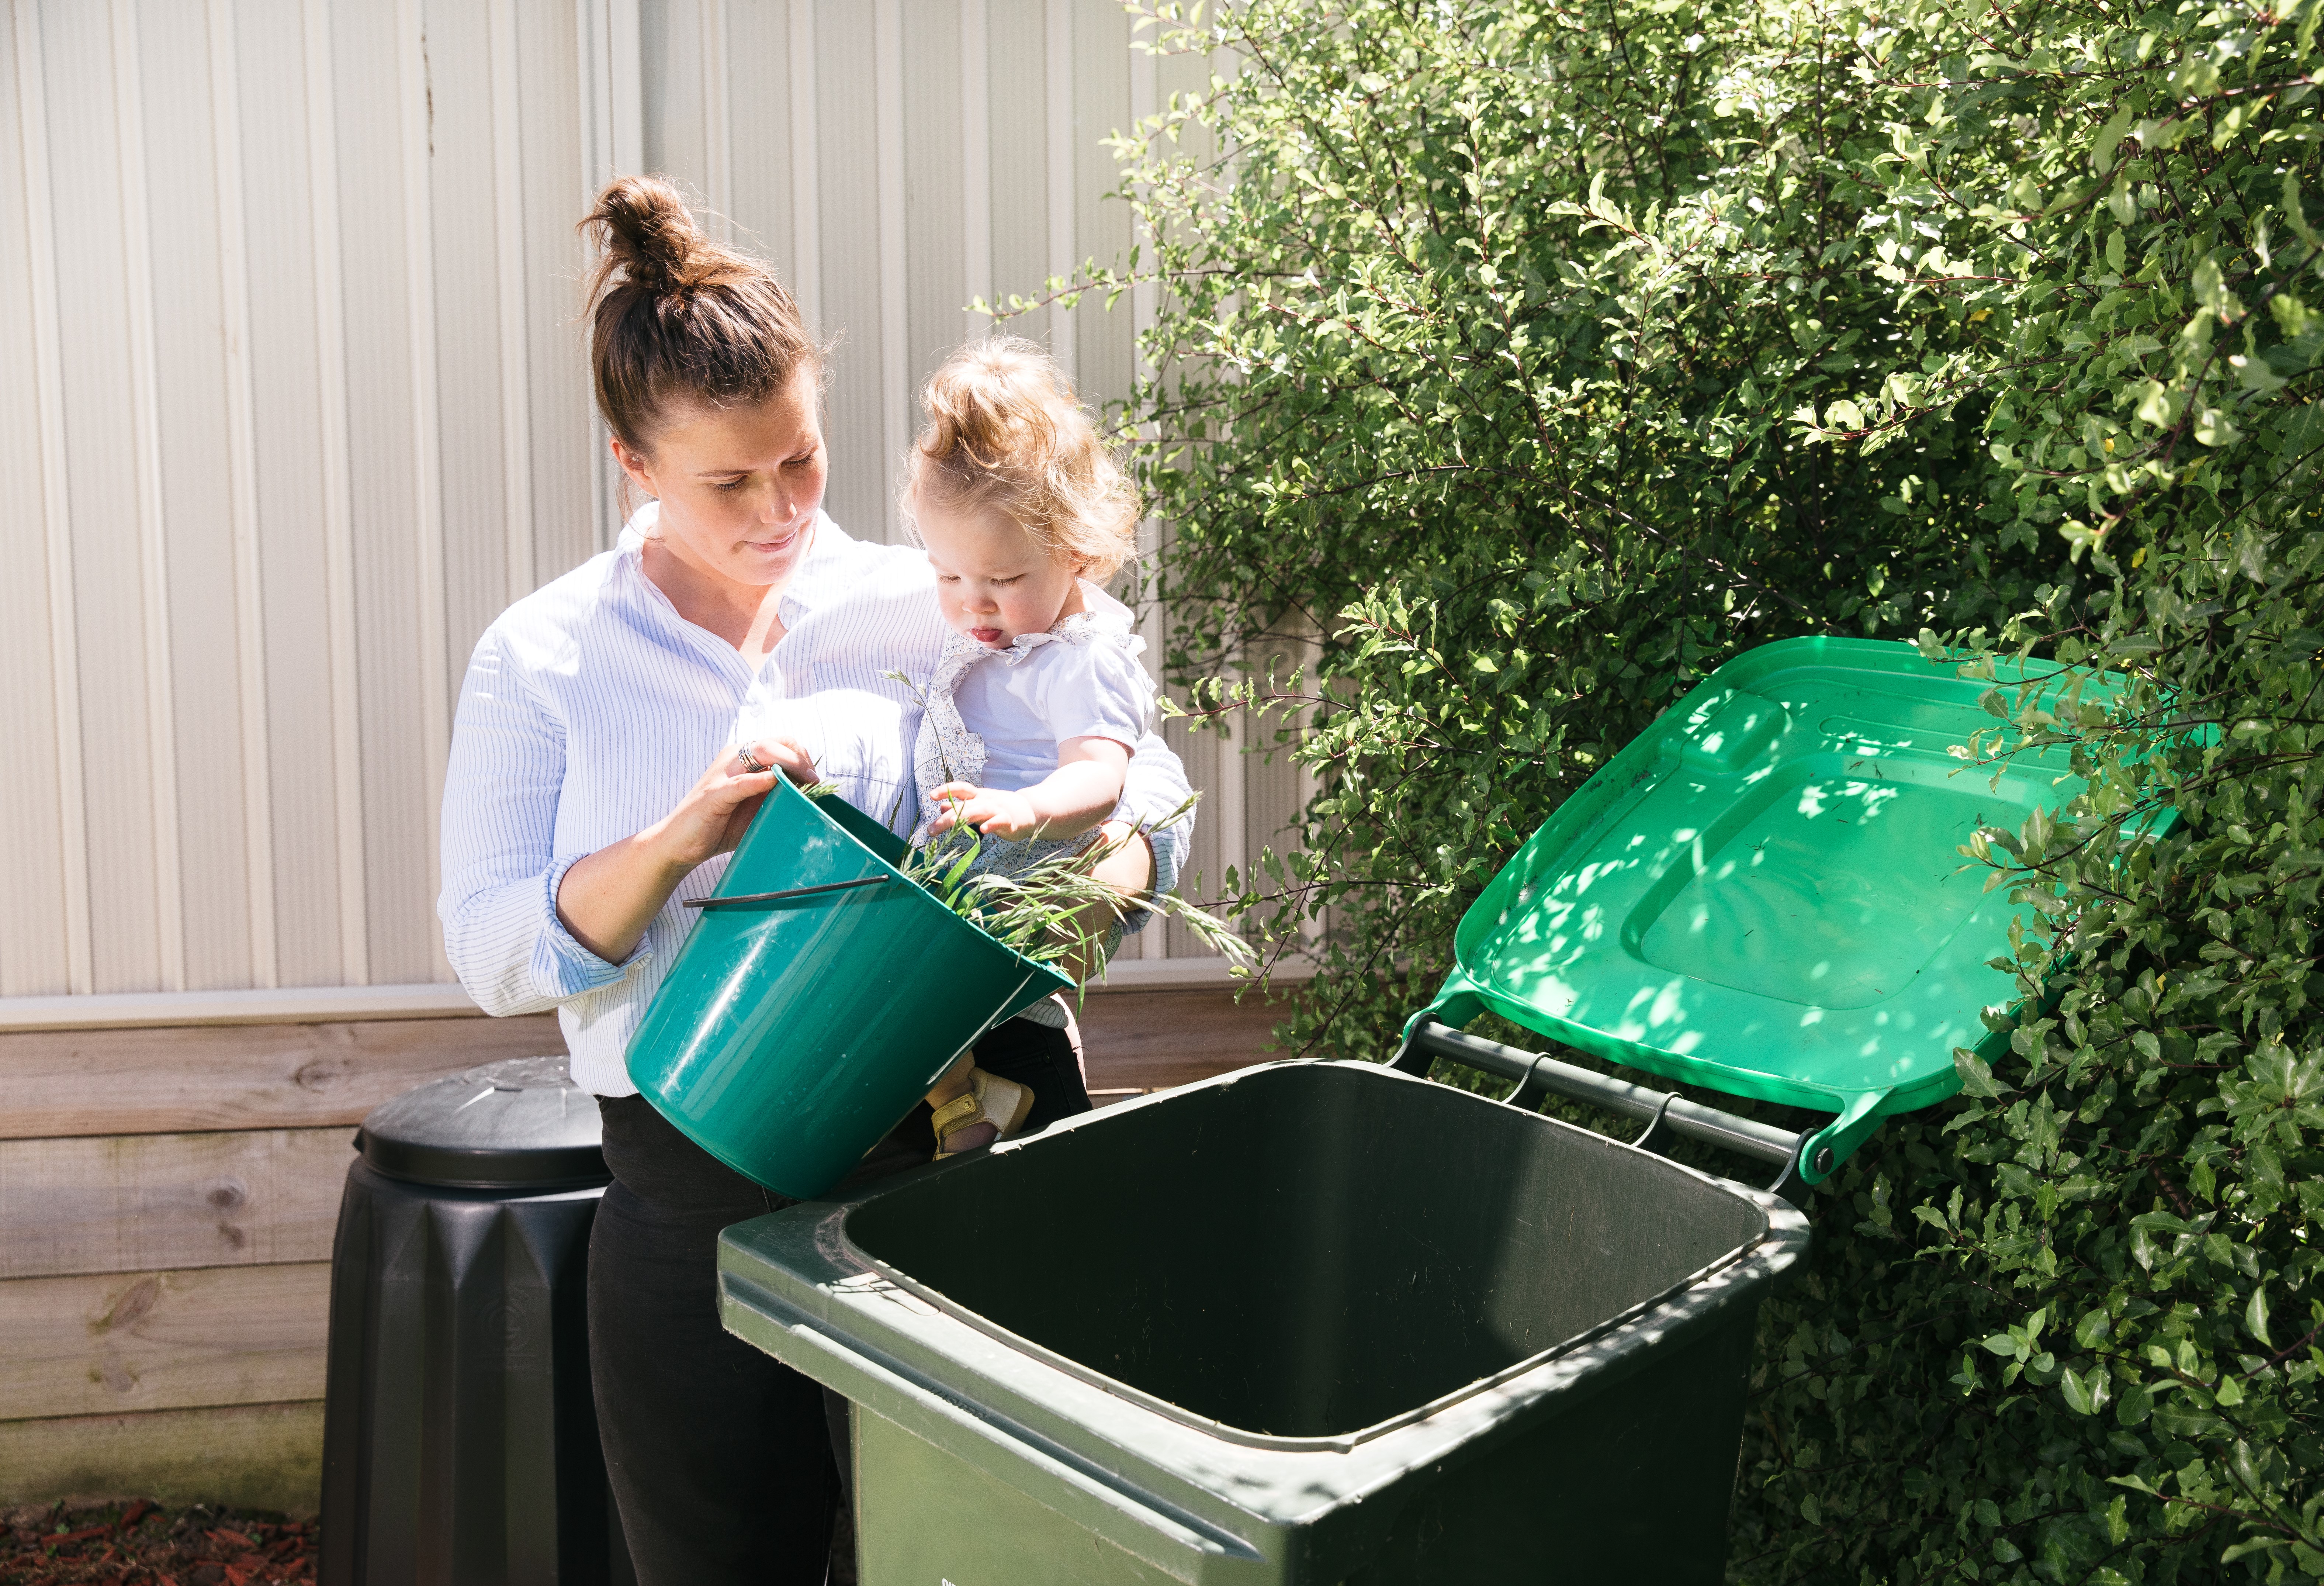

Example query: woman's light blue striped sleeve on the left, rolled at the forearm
[437,630,646,1014]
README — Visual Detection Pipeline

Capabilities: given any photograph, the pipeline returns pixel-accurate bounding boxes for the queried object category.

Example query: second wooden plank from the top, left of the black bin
[0,1128,353,1277]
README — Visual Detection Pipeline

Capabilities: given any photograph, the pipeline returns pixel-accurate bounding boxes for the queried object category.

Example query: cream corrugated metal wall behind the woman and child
[0,0,1297,998]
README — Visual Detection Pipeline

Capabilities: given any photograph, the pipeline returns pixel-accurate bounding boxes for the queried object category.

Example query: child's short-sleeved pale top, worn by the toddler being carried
[953,584,1155,793]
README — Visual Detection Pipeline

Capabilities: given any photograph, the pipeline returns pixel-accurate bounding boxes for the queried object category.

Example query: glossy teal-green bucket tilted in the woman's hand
[627,781,1071,1200]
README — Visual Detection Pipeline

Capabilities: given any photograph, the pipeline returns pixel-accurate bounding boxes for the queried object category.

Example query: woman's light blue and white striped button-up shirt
[437,505,1192,1095]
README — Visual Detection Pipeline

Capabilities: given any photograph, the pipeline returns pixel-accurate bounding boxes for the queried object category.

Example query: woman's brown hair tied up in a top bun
[581,177,823,453]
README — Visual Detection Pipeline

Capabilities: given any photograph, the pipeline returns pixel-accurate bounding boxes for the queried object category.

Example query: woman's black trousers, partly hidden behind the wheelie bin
[588,1019,1090,1586]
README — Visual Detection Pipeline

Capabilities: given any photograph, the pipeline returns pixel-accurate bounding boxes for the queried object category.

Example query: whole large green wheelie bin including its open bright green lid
[720,639,2157,1586]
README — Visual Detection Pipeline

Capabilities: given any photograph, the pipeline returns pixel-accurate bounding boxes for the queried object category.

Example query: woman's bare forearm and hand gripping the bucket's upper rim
[558,737,816,963]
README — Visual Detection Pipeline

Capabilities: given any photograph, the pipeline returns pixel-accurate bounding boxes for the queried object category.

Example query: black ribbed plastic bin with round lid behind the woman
[318,1058,634,1586]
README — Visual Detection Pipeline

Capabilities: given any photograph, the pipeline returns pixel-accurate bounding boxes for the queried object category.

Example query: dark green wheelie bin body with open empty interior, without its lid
[720,1063,1806,1586]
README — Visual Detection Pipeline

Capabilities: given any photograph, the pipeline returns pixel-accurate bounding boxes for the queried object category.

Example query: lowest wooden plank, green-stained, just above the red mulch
[0,1400,323,1514]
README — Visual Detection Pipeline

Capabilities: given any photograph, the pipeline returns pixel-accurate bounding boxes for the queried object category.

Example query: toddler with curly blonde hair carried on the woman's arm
[904,337,1153,1160]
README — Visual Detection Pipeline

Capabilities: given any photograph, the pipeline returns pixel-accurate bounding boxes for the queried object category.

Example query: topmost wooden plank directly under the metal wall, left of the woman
[0,1014,565,1140]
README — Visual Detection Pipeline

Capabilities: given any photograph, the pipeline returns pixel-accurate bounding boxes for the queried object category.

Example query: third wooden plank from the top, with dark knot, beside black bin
[0,1261,330,1421]
